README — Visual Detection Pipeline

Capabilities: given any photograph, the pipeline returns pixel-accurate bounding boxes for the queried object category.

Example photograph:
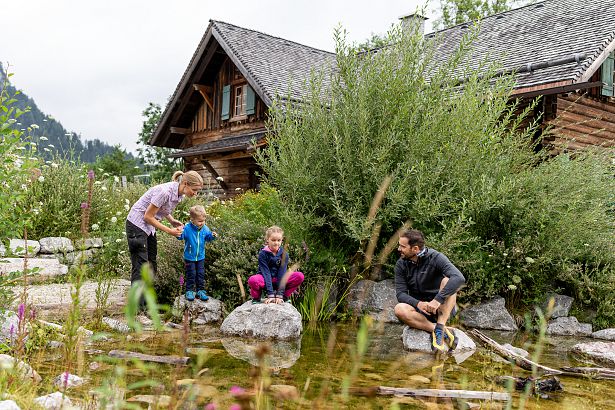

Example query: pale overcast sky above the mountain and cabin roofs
[0,0,434,151]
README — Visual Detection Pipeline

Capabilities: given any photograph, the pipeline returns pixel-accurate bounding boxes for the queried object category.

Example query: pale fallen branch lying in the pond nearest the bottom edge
[350,386,510,401]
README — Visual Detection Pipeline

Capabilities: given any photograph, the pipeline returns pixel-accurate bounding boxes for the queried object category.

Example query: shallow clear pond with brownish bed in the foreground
[30,323,615,409]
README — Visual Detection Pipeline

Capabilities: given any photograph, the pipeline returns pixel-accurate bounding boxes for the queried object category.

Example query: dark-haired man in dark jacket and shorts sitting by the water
[395,229,465,352]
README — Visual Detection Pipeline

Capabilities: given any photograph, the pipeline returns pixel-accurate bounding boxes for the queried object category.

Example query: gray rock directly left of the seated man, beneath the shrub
[347,279,399,323]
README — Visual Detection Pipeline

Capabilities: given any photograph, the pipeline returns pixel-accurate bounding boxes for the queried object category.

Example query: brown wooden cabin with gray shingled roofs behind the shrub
[150,0,615,196]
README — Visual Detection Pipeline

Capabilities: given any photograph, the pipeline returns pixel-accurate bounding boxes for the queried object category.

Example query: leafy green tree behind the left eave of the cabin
[137,102,181,180]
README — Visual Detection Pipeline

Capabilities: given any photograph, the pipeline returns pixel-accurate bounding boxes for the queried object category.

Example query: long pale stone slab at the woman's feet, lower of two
[12,279,130,320]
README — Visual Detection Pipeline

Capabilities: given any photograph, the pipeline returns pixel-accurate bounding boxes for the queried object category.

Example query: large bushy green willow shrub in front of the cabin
[257,25,615,322]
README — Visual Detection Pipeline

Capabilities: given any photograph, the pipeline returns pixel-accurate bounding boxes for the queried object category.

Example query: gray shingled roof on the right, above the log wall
[430,0,615,89]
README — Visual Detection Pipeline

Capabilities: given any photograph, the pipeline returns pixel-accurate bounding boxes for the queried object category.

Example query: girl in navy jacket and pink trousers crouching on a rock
[248,226,303,304]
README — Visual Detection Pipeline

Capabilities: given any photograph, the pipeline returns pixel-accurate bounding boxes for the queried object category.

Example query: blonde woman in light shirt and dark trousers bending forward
[126,171,203,284]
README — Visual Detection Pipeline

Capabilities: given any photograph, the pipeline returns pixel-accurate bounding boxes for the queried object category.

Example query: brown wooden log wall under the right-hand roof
[545,93,615,151]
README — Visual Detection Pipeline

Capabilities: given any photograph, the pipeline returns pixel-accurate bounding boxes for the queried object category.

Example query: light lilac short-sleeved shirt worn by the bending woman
[126,182,184,235]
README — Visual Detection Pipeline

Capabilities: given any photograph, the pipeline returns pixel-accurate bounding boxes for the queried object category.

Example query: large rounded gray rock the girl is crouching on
[220,301,303,340]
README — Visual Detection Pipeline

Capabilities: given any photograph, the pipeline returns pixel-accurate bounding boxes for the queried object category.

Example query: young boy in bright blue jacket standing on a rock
[177,205,218,301]
